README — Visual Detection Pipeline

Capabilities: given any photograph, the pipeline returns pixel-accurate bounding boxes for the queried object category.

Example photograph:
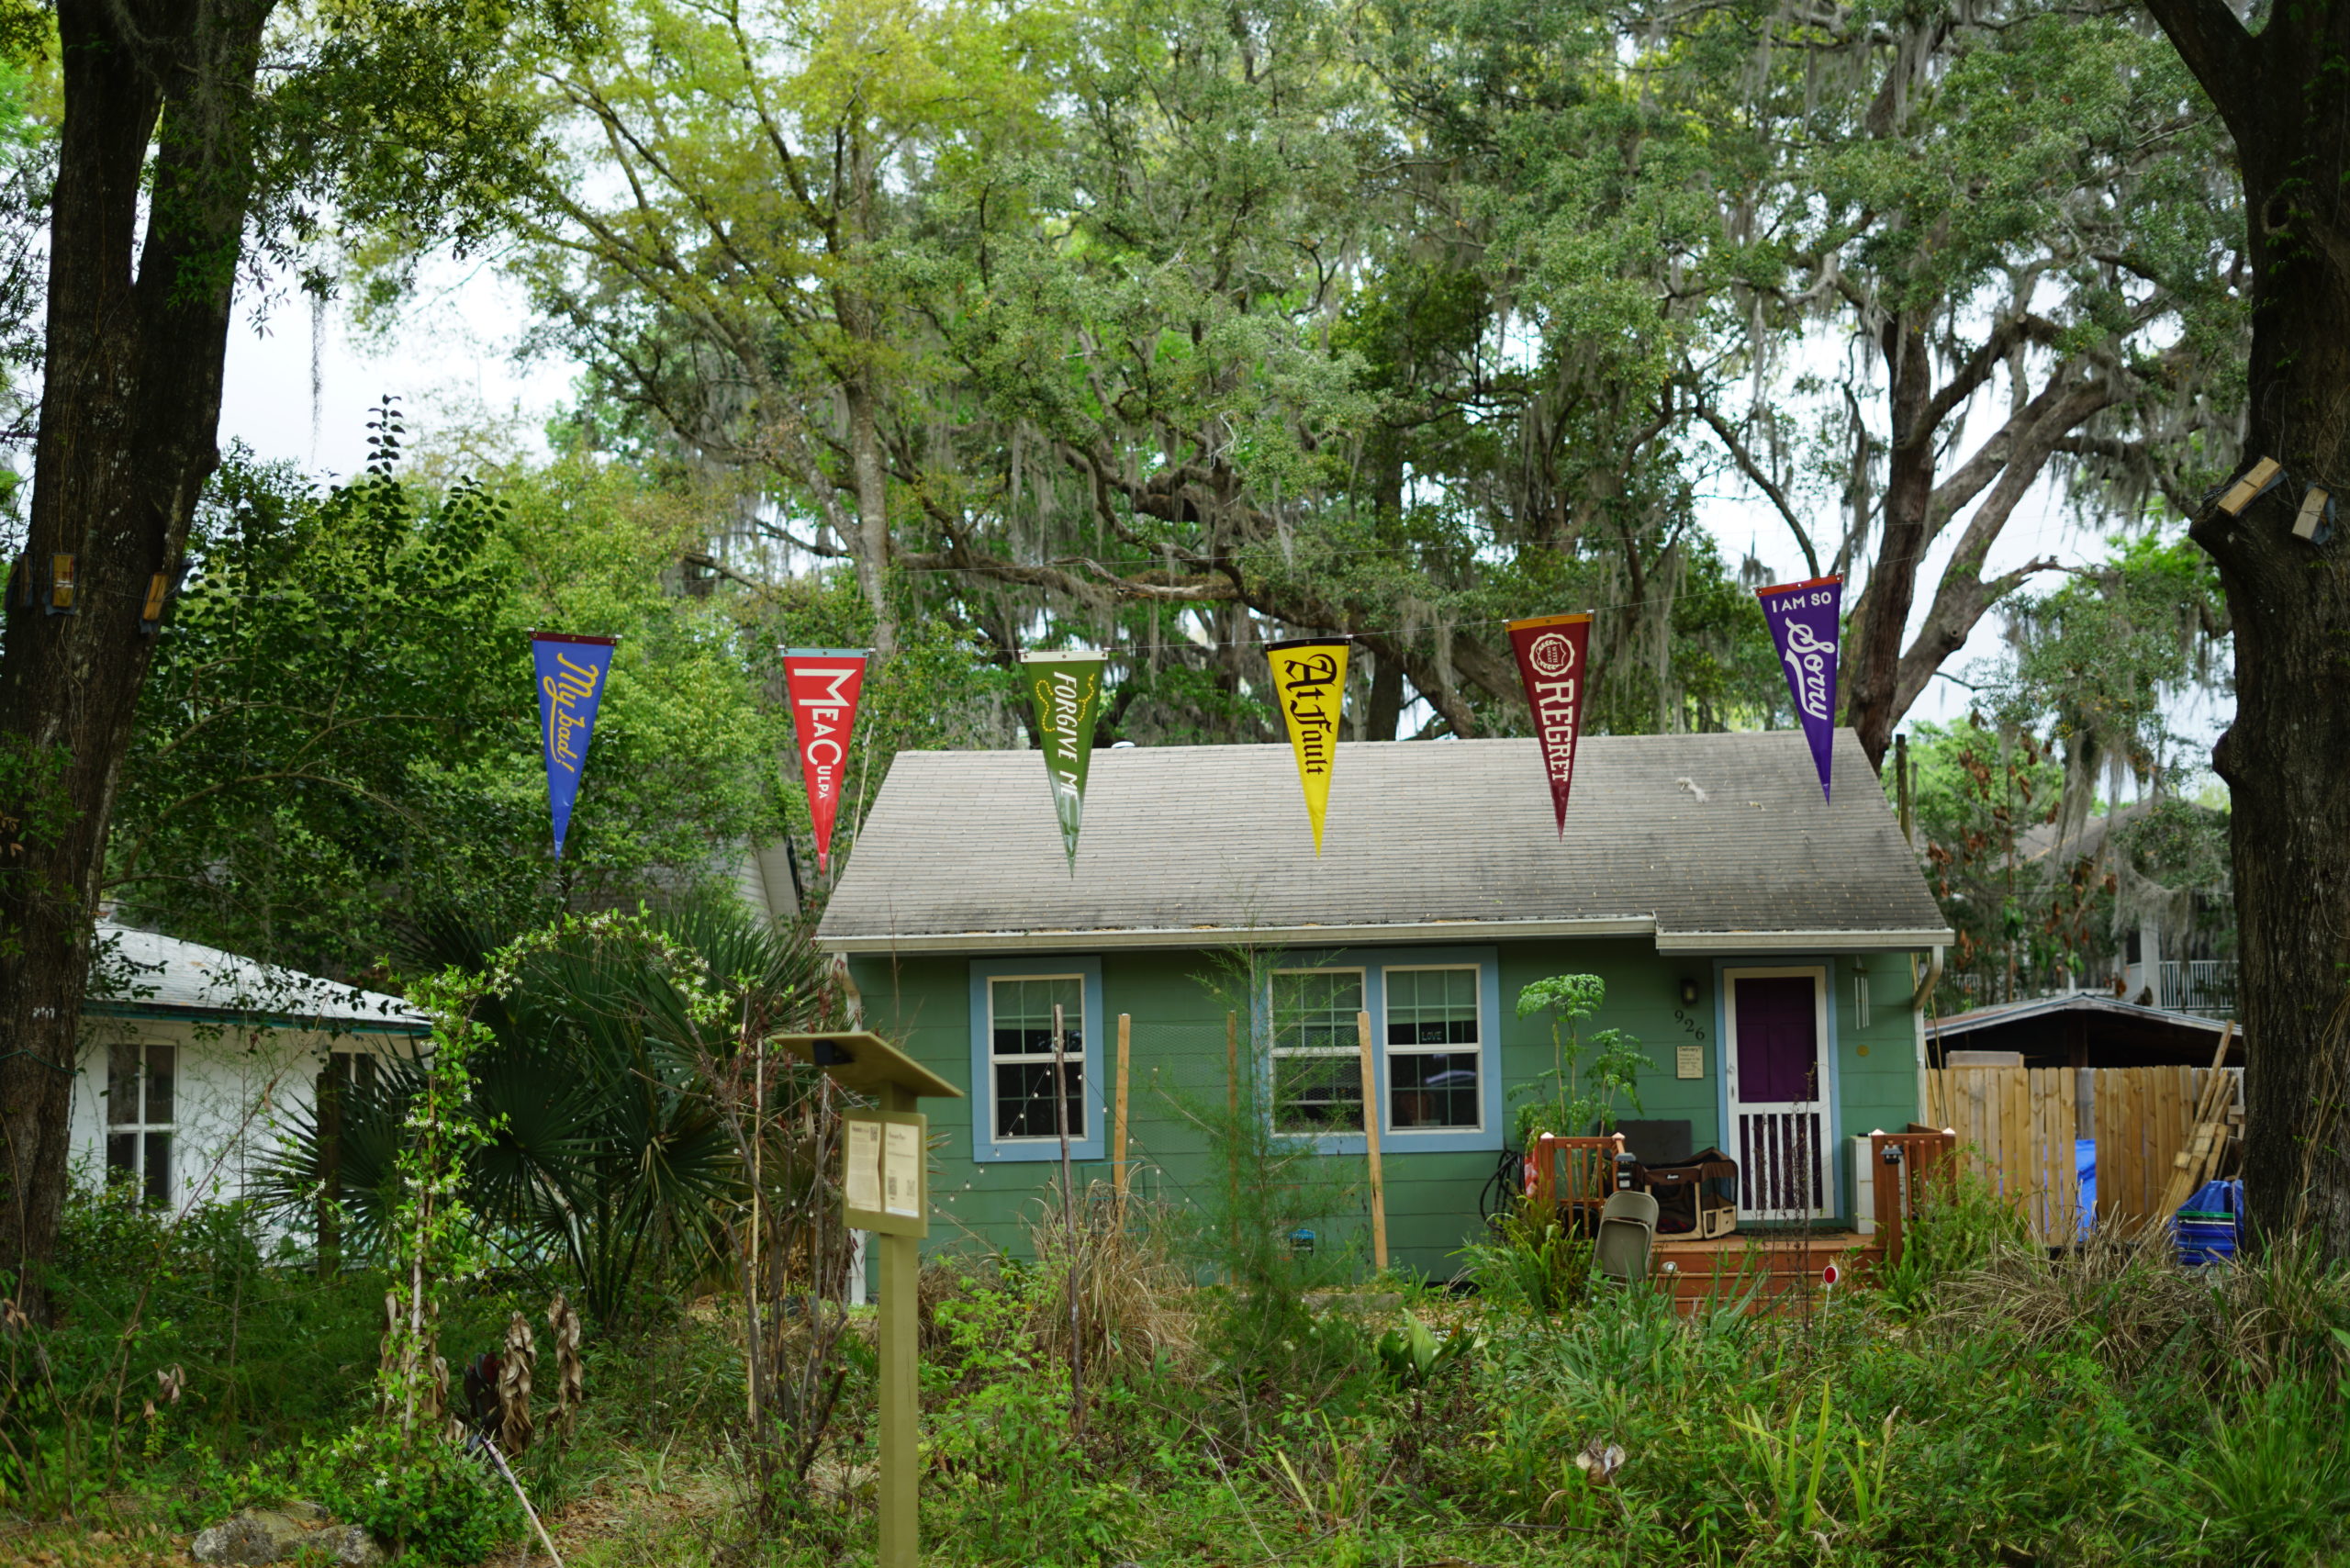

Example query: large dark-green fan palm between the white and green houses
[263,902,825,1321]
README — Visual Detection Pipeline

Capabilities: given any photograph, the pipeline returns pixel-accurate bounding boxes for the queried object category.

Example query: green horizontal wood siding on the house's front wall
[851,938,1918,1276]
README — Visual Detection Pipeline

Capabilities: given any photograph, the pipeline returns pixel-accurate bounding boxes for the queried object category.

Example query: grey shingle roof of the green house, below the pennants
[818,731,1951,952]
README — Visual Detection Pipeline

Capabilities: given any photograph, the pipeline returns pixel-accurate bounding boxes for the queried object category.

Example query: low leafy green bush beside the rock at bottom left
[303,1425,524,1563]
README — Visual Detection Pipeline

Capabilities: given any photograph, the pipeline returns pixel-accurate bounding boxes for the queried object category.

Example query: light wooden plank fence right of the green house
[1927,1068,2240,1246]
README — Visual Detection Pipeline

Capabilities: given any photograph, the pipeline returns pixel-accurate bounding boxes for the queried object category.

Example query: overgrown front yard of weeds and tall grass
[0,1175,2350,1568]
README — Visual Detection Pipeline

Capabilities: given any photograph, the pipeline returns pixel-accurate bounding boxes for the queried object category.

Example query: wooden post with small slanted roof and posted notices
[768,1032,964,1568]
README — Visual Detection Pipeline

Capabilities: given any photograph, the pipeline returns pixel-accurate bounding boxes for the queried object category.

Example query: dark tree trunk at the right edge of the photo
[2150,0,2350,1258]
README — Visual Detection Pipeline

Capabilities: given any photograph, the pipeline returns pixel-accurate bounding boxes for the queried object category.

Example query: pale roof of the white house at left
[84,926,432,1035]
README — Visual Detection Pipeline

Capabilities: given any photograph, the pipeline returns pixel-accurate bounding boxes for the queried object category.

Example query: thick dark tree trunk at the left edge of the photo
[0,0,275,1314]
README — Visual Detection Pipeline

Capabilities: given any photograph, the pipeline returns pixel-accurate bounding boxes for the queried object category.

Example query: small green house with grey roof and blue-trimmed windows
[818,731,1951,1276]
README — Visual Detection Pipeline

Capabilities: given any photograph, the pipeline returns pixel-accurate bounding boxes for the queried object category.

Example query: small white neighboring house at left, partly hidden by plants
[73,926,430,1213]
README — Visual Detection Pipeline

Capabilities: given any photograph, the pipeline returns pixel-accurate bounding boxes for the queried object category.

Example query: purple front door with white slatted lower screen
[1729,973,1829,1220]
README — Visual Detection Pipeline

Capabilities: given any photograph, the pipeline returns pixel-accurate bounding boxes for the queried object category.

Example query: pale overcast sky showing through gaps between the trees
[221,261,2223,766]
